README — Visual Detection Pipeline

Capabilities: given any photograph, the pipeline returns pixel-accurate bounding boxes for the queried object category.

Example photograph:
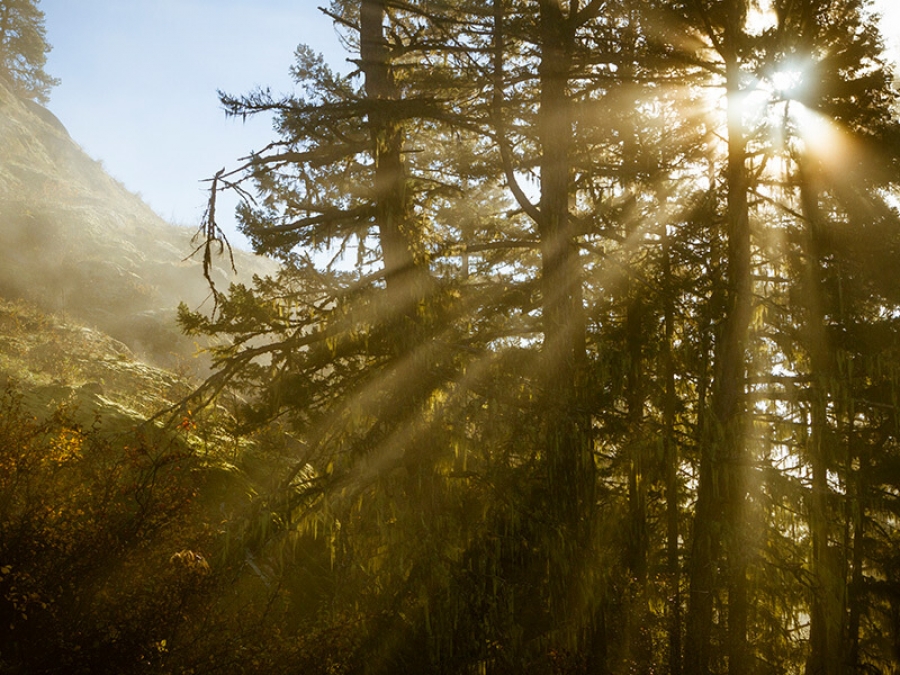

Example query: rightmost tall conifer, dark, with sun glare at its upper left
[774,1,900,674]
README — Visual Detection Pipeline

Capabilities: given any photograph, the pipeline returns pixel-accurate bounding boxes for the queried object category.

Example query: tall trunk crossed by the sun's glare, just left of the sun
[685,0,752,675]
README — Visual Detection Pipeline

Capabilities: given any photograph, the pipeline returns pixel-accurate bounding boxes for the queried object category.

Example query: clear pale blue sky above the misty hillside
[40,0,900,251]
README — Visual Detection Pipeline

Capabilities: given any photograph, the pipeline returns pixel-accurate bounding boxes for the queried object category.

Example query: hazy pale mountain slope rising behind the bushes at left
[0,81,273,365]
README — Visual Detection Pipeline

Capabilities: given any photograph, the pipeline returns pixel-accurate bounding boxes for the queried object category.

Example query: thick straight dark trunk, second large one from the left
[538,0,595,644]
